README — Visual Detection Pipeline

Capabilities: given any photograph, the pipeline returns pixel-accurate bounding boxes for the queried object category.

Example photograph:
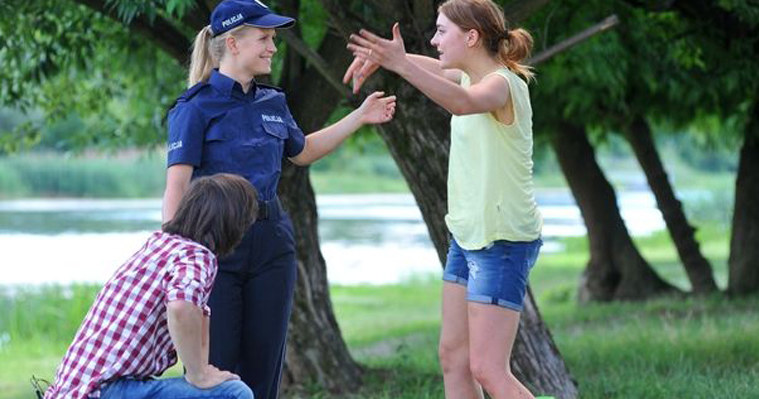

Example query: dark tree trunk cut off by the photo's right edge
[727,101,759,295]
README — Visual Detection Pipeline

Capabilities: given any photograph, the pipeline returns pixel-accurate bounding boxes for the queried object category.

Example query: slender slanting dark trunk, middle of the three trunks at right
[626,116,717,294]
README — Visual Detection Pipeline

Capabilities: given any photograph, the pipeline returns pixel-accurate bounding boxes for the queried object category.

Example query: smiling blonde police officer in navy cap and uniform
[163,0,395,399]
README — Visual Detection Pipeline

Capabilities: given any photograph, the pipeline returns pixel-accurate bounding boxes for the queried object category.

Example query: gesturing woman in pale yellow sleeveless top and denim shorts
[344,0,542,399]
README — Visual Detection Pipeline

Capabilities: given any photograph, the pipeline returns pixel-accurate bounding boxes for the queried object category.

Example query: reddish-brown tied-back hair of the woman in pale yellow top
[438,0,534,80]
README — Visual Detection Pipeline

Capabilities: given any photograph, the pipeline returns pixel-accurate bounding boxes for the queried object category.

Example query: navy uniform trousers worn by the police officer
[208,200,297,399]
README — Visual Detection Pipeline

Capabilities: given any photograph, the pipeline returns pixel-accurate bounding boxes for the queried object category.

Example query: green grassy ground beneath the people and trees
[0,229,759,399]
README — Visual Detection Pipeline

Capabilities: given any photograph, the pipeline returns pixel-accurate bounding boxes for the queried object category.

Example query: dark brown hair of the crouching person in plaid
[163,173,258,256]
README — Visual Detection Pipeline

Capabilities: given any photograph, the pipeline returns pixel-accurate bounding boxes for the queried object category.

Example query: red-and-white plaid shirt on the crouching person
[45,232,216,399]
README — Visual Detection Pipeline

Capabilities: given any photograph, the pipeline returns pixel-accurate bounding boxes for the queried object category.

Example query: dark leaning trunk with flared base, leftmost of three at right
[551,123,677,301]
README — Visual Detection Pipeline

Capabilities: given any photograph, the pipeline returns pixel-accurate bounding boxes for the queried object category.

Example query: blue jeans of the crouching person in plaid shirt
[100,377,253,399]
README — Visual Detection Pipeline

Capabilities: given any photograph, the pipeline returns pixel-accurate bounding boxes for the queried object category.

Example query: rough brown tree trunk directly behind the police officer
[280,29,362,393]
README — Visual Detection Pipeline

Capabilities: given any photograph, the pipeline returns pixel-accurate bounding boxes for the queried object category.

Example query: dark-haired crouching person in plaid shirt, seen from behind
[45,174,258,399]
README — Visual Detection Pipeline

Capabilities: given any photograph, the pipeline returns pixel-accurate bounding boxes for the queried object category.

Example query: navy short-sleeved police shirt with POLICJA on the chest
[168,70,306,200]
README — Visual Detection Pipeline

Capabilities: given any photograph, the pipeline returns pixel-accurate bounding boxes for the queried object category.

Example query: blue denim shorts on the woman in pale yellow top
[443,238,543,312]
